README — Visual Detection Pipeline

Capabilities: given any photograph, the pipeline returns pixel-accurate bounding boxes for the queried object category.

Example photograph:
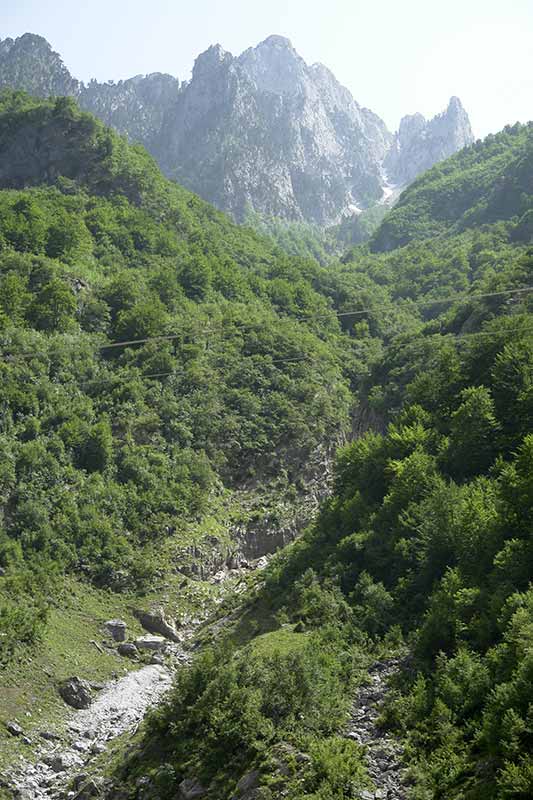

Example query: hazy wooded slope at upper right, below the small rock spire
[371,123,533,251]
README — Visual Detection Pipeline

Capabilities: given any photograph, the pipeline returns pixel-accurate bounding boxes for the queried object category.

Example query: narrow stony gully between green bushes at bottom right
[346,659,409,800]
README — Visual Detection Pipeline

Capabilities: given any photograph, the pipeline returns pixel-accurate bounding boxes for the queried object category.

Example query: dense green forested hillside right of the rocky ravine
[108,126,533,800]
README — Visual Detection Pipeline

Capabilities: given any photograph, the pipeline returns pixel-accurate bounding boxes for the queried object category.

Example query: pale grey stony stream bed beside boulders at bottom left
[9,645,188,800]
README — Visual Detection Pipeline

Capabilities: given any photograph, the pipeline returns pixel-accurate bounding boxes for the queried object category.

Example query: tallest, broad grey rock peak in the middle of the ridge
[158,36,391,224]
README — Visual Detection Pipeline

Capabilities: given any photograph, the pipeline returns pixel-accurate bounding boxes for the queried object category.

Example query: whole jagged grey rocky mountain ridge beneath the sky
[0,34,473,226]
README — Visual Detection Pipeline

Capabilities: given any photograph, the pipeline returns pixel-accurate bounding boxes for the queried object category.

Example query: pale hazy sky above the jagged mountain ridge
[0,0,533,137]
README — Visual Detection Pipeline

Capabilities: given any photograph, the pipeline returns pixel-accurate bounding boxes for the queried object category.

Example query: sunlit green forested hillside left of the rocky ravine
[0,87,357,661]
